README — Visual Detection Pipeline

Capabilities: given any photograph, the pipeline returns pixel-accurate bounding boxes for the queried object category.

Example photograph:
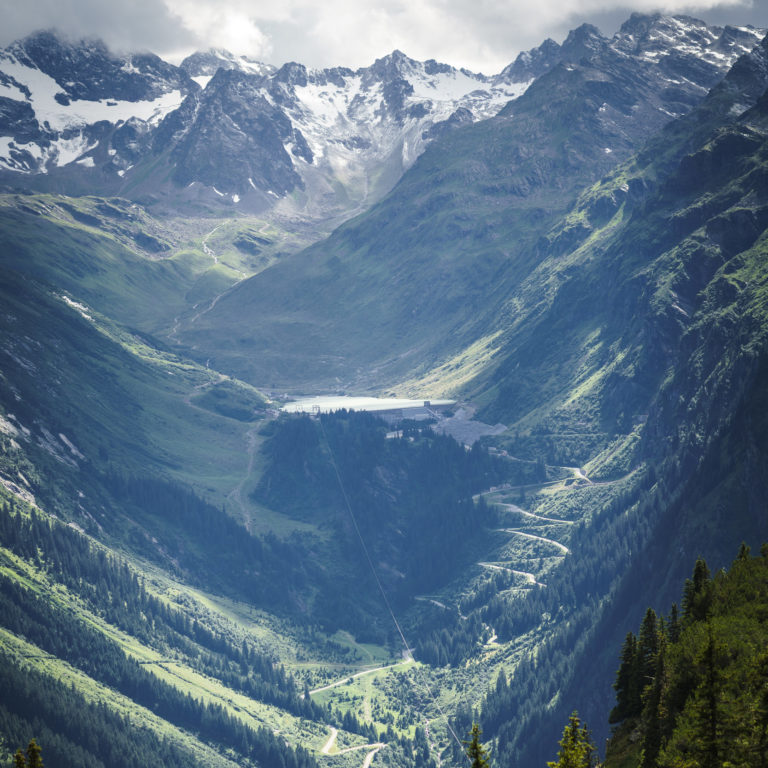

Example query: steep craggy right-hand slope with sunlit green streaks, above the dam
[475,34,768,432]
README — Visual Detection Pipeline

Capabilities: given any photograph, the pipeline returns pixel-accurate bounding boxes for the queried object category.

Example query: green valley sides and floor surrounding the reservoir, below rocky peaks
[0,30,768,767]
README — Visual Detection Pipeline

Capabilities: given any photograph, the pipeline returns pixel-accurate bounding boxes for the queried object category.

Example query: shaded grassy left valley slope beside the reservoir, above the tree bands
[0,269,272,516]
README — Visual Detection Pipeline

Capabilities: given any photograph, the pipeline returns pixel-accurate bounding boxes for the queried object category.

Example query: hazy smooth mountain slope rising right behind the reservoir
[178,41,708,388]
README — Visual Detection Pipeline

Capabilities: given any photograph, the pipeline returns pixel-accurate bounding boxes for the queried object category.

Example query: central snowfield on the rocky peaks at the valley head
[276,52,531,208]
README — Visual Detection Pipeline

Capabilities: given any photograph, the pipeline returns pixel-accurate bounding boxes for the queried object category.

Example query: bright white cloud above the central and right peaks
[249,0,768,73]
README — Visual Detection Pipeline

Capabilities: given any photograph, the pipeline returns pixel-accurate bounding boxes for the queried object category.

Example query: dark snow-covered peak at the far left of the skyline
[0,32,197,173]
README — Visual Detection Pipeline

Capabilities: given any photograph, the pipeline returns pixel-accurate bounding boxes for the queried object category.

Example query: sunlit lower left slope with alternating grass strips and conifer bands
[0,490,370,768]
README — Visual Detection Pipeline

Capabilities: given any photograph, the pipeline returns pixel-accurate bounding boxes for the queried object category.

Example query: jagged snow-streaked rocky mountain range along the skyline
[0,15,760,215]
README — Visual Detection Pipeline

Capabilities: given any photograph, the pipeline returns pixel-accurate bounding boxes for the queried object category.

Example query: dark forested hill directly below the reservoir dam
[255,411,509,640]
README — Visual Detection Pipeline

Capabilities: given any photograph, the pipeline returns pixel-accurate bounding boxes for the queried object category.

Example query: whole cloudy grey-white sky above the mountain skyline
[0,0,768,74]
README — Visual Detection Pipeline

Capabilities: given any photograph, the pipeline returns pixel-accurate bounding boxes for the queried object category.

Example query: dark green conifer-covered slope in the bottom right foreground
[606,545,768,768]
